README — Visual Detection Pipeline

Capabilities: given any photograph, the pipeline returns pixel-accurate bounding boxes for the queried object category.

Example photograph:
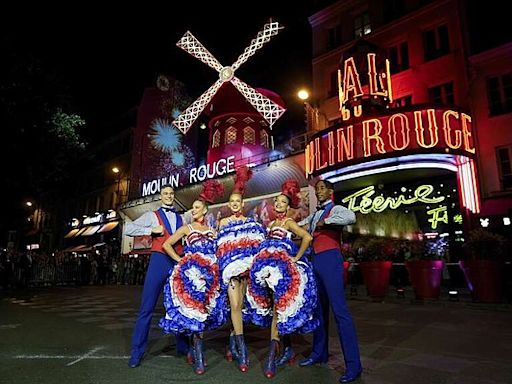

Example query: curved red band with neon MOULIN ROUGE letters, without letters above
[305,108,475,177]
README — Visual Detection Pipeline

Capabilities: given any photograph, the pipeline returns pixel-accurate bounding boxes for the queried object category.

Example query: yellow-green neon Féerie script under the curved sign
[342,184,445,214]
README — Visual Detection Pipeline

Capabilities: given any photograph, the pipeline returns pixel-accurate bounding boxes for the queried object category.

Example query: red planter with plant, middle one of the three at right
[405,238,448,300]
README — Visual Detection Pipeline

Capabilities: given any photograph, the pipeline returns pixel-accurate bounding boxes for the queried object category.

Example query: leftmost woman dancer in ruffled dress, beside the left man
[159,182,227,375]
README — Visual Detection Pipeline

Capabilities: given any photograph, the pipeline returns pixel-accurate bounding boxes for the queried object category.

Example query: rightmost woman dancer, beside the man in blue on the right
[246,180,319,379]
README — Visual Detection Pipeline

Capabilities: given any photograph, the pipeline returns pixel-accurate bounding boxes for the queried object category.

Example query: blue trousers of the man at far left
[132,252,188,357]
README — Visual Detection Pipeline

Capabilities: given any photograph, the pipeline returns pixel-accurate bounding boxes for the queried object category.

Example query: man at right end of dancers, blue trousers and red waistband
[299,180,363,383]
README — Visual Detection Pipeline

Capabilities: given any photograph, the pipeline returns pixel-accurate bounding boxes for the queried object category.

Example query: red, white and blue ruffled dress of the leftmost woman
[159,225,227,335]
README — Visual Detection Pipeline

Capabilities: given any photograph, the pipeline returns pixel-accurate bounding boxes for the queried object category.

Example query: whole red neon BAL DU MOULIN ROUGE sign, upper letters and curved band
[305,53,475,176]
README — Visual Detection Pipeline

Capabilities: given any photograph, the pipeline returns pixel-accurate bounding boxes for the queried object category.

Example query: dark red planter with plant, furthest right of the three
[459,228,505,303]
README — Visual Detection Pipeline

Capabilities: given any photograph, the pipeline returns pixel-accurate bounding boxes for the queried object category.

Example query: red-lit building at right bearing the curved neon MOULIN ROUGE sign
[305,1,512,257]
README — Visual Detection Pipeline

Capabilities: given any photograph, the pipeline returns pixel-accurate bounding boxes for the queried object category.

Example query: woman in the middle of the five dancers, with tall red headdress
[217,167,265,372]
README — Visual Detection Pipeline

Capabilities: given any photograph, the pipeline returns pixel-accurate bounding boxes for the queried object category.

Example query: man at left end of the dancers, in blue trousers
[124,185,188,368]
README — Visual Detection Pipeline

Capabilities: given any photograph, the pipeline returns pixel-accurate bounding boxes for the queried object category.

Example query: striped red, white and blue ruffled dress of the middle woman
[217,218,265,285]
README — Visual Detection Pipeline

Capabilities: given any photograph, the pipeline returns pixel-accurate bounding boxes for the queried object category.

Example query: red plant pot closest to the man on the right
[359,237,394,298]
